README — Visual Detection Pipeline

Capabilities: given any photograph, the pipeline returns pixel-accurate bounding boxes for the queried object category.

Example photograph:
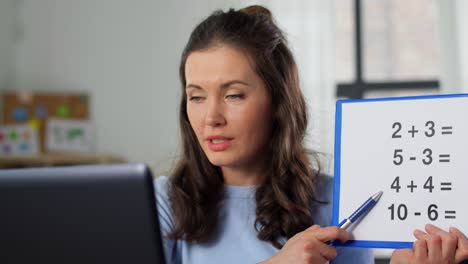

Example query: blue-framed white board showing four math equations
[333,94,468,248]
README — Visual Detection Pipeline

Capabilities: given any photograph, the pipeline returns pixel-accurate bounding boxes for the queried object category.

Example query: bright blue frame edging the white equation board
[332,94,468,248]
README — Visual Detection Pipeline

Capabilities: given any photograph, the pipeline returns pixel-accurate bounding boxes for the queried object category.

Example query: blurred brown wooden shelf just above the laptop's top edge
[0,153,126,168]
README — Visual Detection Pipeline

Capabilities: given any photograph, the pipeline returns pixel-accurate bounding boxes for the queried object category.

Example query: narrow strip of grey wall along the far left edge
[0,0,18,92]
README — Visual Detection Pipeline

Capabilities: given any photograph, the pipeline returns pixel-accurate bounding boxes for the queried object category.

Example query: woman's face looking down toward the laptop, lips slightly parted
[185,45,272,169]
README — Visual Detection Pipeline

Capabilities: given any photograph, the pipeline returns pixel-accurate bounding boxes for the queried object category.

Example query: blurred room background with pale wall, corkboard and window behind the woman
[0,0,468,260]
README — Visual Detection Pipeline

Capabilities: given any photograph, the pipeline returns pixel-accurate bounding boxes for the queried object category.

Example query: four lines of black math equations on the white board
[387,120,457,221]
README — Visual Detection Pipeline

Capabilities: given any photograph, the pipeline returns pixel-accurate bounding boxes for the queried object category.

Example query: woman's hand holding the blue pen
[262,225,350,264]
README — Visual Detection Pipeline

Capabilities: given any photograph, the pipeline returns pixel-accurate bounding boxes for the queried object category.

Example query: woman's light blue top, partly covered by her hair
[155,176,374,264]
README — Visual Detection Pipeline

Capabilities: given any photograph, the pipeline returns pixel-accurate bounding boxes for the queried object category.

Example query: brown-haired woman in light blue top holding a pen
[156,6,468,263]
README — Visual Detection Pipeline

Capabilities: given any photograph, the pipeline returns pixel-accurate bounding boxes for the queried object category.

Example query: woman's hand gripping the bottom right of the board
[390,224,468,264]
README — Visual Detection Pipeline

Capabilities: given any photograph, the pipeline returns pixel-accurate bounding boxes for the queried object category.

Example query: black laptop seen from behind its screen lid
[0,164,165,264]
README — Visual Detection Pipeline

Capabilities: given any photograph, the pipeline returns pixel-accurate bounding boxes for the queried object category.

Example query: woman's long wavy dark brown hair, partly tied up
[168,6,317,248]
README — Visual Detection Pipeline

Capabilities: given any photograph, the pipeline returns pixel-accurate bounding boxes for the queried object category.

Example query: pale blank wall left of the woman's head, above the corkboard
[15,0,225,174]
